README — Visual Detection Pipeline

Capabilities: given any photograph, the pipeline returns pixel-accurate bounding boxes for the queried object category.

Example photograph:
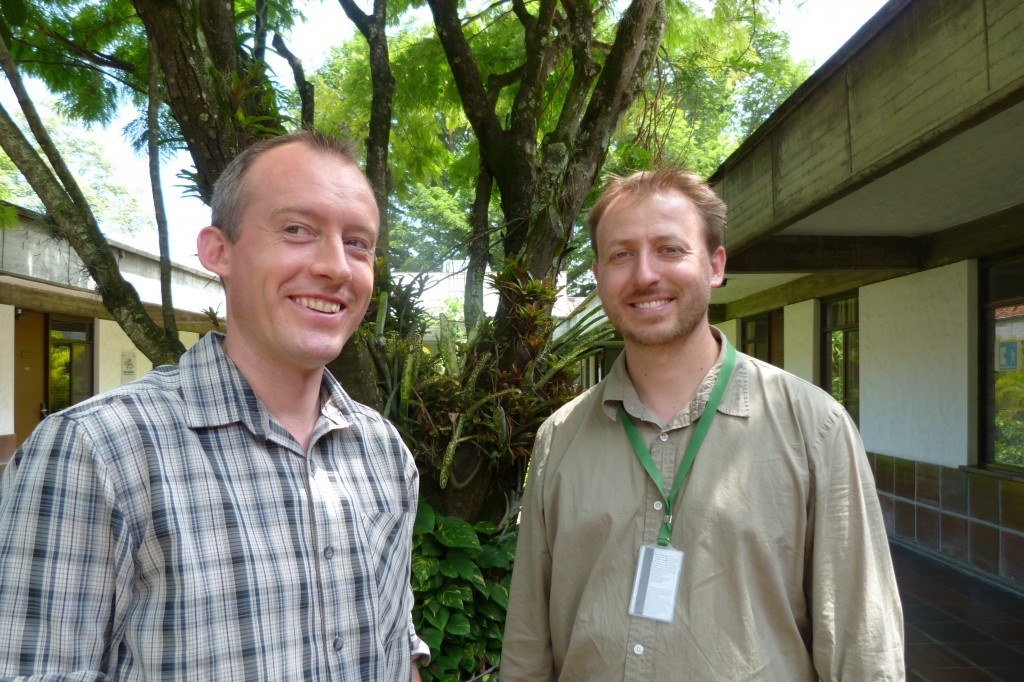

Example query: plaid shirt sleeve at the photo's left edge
[0,415,132,680]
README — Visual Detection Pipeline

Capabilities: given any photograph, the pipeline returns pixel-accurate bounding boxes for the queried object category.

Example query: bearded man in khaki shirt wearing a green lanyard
[502,170,904,682]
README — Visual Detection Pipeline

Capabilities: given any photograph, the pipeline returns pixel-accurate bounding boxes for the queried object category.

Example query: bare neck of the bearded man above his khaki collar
[626,325,719,424]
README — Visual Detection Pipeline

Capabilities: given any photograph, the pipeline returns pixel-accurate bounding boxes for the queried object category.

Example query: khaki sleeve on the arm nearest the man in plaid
[501,422,556,682]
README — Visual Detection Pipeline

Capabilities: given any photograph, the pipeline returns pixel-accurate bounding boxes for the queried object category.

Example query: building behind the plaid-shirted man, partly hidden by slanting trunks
[0,205,224,468]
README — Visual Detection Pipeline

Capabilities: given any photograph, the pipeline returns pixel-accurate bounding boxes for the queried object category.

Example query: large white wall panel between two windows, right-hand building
[860,260,978,466]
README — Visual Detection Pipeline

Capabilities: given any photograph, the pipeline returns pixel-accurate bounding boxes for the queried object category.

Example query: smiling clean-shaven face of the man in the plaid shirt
[199,142,380,372]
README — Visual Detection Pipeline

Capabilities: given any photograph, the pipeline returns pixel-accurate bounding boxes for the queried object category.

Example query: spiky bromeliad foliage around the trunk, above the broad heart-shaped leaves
[362,262,611,520]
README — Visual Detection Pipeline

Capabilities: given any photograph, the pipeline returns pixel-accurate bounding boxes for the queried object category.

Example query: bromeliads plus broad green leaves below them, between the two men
[361,262,611,681]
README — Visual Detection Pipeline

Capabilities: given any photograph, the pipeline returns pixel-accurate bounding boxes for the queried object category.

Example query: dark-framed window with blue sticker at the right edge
[982,254,1024,467]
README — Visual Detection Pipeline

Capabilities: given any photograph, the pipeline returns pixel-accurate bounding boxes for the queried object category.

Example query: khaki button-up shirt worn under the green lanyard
[502,330,904,682]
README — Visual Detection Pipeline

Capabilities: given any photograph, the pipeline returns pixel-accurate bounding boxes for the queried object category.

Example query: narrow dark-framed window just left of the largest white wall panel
[821,294,860,425]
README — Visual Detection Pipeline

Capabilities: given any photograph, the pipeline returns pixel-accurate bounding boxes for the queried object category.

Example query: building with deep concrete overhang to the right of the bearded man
[711,0,1024,588]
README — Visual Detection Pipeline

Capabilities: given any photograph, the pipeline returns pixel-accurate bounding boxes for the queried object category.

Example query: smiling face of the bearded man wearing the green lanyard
[594,189,725,347]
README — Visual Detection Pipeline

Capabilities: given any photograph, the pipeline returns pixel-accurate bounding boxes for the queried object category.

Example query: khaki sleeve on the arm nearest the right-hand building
[807,409,904,680]
